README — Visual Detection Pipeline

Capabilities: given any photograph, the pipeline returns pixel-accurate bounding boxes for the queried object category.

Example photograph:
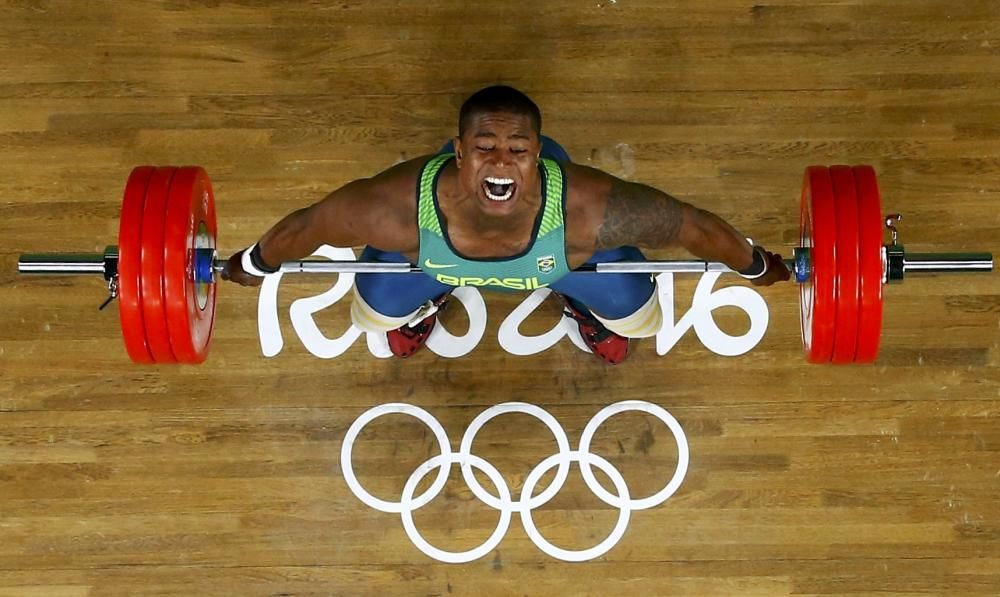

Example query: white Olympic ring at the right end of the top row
[578,400,690,510]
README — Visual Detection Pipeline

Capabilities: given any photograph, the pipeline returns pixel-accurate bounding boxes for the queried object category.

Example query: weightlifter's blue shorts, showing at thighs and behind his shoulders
[355,135,656,319]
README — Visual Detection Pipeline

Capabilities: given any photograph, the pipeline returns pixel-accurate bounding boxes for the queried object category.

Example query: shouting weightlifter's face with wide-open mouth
[455,112,541,215]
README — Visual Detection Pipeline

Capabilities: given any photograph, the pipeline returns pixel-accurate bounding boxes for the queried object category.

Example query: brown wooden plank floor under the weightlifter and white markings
[0,0,1000,597]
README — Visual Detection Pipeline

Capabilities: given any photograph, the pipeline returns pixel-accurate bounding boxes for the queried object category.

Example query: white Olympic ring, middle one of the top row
[458,402,573,512]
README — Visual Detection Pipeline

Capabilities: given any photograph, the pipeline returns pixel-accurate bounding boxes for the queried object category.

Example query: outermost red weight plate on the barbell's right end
[854,166,884,363]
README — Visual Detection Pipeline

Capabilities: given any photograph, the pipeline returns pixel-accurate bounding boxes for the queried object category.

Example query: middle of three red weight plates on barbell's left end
[142,167,177,363]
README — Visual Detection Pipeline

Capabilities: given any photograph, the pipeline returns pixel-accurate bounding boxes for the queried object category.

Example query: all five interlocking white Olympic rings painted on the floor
[340,400,689,563]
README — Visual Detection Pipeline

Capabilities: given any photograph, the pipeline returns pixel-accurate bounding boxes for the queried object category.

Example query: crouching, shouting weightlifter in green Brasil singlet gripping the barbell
[222,86,790,364]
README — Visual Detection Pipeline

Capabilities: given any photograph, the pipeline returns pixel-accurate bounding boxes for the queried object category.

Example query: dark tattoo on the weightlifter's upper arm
[597,180,684,249]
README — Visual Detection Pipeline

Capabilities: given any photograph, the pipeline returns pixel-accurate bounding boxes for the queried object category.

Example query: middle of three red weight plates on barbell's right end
[830,166,858,364]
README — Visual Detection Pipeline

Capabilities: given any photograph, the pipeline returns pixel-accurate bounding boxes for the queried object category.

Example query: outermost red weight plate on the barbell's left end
[118,166,155,363]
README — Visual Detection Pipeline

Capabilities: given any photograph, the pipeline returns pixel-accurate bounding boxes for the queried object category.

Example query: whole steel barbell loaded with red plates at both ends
[18,166,993,363]
